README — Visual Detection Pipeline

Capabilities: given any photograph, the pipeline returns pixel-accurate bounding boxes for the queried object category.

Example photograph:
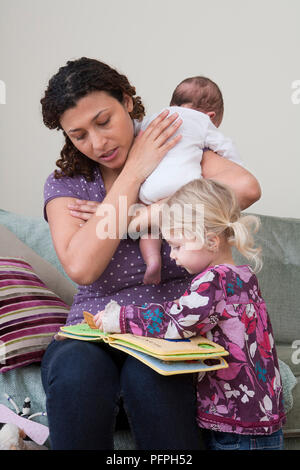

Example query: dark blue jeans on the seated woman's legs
[42,339,201,450]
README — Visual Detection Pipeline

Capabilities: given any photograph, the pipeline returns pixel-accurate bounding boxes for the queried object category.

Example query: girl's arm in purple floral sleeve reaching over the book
[94,270,223,339]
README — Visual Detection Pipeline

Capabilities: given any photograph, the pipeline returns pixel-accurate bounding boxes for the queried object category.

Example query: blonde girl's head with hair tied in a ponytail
[161,179,261,273]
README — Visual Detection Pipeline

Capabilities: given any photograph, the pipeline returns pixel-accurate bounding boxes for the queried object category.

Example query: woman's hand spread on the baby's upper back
[124,110,182,184]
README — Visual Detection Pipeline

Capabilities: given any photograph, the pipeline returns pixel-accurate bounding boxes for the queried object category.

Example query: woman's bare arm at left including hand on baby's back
[46,113,181,285]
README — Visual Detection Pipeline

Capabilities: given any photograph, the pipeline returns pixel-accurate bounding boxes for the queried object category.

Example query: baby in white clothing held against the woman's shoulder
[135,77,242,284]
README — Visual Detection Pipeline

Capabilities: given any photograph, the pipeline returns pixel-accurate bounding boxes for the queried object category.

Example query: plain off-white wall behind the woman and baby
[0,0,300,217]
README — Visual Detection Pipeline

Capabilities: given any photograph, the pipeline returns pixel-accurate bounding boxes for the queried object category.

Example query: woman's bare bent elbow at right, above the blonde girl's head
[201,150,261,210]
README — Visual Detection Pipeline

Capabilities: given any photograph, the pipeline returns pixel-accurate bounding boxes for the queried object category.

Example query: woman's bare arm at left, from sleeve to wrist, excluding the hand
[46,174,140,285]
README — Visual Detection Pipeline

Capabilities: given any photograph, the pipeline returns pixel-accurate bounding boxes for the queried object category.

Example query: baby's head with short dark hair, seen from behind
[170,77,224,127]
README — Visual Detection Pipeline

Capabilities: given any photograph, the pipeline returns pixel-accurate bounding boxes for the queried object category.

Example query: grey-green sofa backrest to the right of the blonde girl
[234,215,300,344]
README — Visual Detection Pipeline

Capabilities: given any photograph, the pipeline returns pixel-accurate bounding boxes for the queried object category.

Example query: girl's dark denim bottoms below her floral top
[203,429,283,450]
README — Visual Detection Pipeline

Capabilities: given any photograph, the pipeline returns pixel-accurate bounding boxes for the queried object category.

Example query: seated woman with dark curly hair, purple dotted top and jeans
[41,58,259,450]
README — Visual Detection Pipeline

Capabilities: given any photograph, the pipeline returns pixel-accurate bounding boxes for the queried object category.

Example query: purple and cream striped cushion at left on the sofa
[0,257,70,372]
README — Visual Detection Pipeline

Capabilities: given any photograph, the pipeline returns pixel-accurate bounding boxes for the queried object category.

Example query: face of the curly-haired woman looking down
[60,91,134,170]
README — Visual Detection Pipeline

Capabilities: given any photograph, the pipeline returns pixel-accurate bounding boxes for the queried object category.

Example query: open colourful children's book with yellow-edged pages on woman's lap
[58,312,229,375]
